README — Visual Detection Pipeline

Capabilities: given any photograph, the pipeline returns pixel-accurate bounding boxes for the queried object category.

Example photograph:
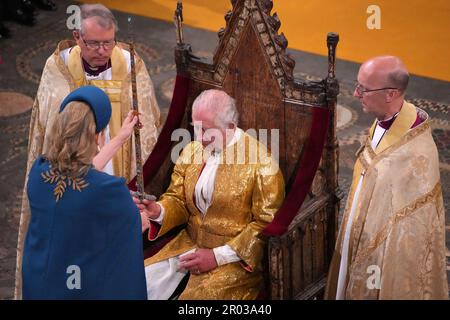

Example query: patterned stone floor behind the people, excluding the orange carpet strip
[0,0,450,299]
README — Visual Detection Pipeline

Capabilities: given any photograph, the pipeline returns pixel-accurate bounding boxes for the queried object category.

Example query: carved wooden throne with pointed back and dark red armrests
[134,0,340,299]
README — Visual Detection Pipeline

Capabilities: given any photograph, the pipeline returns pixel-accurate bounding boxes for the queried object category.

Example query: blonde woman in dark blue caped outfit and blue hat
[22,86,147,299]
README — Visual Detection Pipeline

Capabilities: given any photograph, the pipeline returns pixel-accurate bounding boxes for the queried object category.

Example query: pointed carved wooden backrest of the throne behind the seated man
[172,0,334,190]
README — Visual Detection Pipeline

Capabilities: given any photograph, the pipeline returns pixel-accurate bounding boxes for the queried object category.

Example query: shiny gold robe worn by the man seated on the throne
[145,134,284,299]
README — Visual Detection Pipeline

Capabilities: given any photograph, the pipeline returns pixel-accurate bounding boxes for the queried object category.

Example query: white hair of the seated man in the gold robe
[192,89,239,129]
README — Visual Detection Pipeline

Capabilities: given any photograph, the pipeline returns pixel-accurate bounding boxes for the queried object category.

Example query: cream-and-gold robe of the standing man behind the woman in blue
[15,40,160,299]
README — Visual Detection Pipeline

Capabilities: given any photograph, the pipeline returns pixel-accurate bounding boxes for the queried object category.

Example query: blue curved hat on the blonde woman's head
[59,86,112,133]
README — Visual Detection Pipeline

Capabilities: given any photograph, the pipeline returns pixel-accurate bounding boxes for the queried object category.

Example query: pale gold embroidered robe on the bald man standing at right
[325,102,448,300]
